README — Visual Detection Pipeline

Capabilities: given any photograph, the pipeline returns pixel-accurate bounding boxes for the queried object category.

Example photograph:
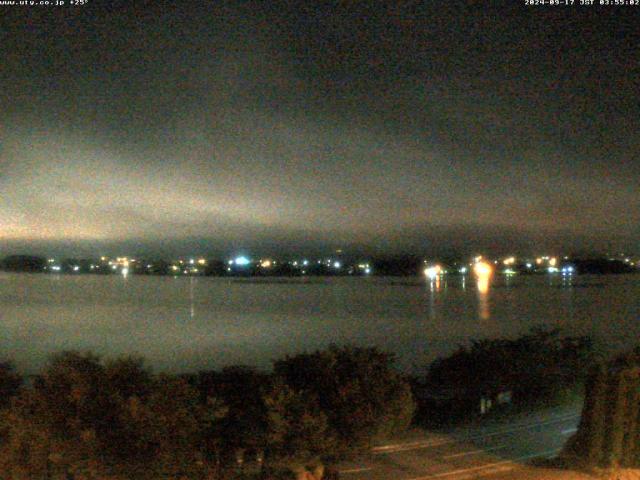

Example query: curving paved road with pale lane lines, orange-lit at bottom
[340,406,580,480]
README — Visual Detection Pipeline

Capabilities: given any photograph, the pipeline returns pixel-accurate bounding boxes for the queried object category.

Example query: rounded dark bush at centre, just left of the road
[274,346,415,456]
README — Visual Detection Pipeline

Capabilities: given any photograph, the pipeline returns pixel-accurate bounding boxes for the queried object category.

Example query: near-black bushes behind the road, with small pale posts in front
[414,328,595,426]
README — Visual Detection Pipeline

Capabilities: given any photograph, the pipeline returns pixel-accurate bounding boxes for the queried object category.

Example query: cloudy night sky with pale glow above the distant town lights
[0,0,640,254]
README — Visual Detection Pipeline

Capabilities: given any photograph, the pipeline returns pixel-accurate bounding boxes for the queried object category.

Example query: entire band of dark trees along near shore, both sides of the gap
[0,329,592,480]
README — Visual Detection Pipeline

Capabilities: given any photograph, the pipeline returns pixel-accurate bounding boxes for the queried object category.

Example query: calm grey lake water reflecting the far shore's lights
[0,273,640,373]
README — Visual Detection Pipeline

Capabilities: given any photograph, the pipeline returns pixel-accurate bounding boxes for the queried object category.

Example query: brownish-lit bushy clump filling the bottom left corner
[0,352,225,479]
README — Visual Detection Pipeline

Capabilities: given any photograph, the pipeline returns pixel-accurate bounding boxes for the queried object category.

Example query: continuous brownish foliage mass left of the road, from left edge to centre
[0,347,413,480]
